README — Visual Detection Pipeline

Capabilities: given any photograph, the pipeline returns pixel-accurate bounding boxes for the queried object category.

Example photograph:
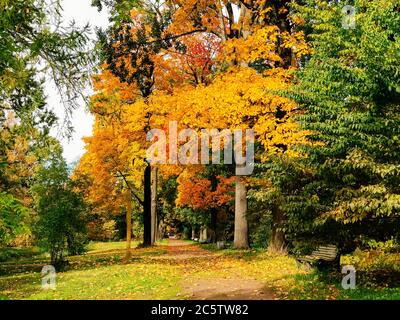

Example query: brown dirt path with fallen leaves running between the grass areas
[160,239,275,300]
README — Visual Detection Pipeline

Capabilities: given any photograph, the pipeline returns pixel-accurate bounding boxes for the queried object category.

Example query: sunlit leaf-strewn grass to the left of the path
[0,242,180,300]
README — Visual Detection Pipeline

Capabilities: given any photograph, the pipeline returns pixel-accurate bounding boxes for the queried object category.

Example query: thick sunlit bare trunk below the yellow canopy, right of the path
[233,176,249,249]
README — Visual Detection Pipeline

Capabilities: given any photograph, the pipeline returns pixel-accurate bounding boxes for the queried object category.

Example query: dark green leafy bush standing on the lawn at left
[31,148,86,266]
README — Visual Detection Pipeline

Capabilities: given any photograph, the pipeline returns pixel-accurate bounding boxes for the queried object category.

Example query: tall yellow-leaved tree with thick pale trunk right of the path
[158,1,309,248]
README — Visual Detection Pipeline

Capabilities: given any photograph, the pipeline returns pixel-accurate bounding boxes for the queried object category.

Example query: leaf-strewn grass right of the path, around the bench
[201,244,400,300]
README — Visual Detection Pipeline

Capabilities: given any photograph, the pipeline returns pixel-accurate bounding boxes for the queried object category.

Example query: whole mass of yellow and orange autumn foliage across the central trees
[73,0,310,212]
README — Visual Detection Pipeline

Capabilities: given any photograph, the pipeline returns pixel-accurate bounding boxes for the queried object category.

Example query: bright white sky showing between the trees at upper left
[46,0,108,163]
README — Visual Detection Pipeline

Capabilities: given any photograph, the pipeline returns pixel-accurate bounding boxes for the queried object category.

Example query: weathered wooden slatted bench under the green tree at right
[297,245,340,270]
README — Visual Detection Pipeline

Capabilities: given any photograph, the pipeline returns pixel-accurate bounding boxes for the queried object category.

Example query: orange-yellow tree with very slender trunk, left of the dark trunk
[74,71,145,254]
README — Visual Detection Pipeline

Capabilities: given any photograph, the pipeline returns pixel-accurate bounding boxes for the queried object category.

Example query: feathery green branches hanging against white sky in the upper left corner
[0,0,94,132]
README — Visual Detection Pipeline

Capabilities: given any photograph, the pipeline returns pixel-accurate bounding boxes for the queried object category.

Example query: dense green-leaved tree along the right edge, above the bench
[284,0,400,245]
